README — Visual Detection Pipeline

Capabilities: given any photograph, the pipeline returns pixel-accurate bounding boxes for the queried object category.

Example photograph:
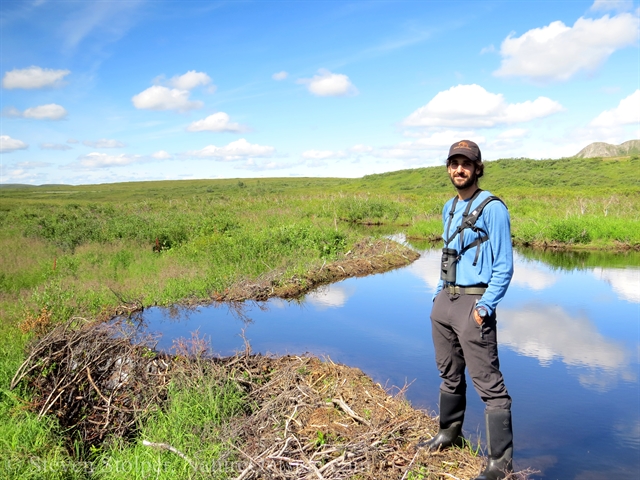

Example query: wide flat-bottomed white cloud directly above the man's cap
[403,84,563,127]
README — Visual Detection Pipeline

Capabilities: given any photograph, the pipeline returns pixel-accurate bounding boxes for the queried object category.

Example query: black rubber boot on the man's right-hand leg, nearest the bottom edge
[475,410,513,480]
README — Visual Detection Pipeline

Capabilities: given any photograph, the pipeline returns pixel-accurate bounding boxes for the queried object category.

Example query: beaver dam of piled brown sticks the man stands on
[11,242,528,480]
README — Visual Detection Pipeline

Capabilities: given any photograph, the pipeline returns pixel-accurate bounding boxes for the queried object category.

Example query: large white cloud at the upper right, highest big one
[494,13,638,82]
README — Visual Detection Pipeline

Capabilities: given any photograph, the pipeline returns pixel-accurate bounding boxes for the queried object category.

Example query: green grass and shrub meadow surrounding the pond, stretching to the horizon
[0,156,640,478]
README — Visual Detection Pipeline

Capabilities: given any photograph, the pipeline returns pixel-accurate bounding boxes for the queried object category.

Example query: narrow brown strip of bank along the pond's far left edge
[211,239,420,302]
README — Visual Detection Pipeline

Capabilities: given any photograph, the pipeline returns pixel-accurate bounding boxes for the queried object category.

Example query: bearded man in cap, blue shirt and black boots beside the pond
[422,140,513,480]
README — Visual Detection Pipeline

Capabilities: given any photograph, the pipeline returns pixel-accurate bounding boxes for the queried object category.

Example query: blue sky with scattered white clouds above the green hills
[0,0,640,185]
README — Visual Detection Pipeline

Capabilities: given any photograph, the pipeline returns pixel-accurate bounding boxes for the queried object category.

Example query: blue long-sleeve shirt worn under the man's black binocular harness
[434,191,513,314]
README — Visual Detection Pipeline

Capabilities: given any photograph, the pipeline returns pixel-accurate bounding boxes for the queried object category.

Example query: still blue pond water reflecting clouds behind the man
[144,246,640,480]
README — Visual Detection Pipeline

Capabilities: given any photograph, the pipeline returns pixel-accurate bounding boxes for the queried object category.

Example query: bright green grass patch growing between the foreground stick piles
[94,376,248,480]
